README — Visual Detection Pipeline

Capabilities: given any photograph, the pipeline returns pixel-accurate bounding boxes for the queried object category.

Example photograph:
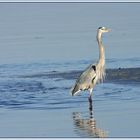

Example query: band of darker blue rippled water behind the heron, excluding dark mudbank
[0,58,140,109]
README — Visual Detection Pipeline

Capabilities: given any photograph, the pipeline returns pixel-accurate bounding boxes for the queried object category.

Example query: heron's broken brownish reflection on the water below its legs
[73,106,107,138]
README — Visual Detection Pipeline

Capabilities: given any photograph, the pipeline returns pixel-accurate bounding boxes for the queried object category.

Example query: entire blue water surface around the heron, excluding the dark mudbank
[0,3,140,137]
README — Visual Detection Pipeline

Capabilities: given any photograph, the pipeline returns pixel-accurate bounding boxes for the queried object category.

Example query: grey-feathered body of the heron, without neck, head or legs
[72,59,105,95]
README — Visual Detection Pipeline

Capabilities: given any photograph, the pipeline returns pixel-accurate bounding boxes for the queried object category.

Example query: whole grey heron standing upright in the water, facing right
[71,27,110,109]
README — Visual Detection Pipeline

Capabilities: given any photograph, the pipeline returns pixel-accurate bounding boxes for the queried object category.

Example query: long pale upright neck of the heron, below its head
[97,31,105,66]
